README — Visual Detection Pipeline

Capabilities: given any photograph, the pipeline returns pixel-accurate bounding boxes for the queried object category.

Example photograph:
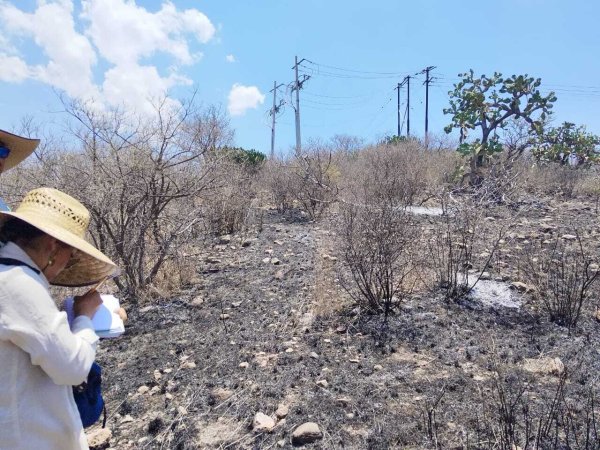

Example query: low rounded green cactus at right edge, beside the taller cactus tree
[533,122,600,166]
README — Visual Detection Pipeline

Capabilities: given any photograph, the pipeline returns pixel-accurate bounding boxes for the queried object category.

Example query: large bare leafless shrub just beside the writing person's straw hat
[21,100,231,300]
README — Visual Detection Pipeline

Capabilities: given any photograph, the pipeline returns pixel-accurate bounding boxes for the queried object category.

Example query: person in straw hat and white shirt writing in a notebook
[0,188,117,450]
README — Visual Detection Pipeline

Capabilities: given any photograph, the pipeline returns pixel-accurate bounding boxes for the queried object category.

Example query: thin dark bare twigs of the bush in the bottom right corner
[465,361,600,450]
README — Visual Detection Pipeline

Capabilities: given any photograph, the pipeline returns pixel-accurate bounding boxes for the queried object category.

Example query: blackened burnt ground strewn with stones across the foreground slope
[91,200,600,449]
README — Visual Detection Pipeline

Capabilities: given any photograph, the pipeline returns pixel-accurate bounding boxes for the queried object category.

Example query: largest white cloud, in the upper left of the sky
[0,0,215,110]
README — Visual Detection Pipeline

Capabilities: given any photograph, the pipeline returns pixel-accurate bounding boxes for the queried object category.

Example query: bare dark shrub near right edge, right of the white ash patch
[524,234,598,331]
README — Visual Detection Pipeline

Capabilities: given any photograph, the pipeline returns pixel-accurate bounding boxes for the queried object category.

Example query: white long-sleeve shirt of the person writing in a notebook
[0,242,98,450]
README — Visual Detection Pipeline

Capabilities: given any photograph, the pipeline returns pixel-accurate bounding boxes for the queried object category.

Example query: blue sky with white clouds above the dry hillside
[0,0,600,154]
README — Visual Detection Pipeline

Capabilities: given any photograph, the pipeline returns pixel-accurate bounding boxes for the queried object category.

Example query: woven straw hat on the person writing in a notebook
[0,188,117,286]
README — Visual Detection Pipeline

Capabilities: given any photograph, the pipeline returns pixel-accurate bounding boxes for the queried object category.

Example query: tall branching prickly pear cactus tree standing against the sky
[444,70,556,184]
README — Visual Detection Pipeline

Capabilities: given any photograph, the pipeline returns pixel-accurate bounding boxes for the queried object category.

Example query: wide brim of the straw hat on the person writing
[0,211,119,287]
